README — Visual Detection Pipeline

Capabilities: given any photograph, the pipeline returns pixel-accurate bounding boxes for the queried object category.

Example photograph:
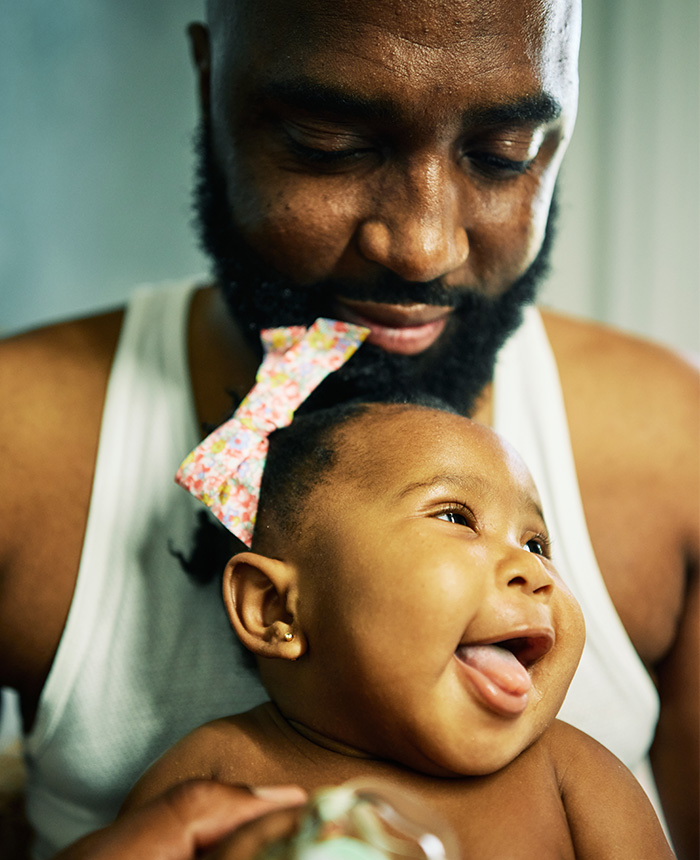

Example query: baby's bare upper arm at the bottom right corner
[551,722,673,860]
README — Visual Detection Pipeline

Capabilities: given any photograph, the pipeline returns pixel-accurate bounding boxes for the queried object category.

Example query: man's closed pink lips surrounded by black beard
[334,298,453,355]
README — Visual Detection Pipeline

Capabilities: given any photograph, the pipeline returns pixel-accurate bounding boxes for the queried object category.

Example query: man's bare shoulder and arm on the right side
[545,314,700,857]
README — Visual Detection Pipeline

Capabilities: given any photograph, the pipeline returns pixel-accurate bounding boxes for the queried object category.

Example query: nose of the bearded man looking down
[357,157,469,281]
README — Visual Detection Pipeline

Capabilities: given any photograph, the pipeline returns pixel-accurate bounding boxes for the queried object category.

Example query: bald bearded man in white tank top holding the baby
[0,0,700,857]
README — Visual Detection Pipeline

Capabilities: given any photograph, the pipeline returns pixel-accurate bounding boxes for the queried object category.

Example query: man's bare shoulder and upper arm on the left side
[0,312,122,699]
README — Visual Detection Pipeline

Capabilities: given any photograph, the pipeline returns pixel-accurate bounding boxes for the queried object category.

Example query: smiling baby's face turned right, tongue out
[287,407,584,776]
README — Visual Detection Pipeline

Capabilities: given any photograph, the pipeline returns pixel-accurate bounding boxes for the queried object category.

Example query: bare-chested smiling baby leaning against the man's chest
[127,404,672,860]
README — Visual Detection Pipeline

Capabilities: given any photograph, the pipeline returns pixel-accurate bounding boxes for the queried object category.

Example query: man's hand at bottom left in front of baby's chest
[54,780,306,860]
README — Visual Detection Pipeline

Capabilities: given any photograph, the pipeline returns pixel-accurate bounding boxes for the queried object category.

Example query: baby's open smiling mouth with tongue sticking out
[455,630,554,716]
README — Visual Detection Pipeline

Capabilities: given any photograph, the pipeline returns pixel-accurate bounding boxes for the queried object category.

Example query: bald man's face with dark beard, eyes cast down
[193,0,578,408]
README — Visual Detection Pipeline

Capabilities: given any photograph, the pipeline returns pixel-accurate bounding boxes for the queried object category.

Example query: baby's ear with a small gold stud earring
[223,552,306,660]
